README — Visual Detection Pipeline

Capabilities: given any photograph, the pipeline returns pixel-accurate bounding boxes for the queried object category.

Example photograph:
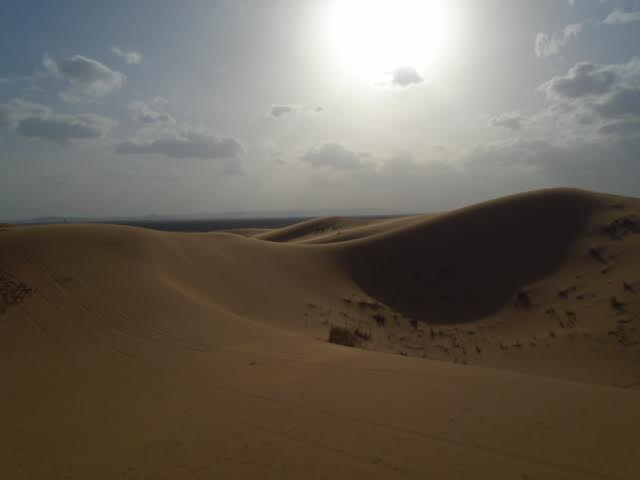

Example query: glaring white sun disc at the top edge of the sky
[330,0,448,81]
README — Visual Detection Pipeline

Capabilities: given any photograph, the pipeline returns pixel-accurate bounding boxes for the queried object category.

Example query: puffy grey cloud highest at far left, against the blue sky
[43,55,126,102]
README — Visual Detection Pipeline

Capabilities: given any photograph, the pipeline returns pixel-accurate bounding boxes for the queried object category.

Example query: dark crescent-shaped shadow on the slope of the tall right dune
[342,189,598,324]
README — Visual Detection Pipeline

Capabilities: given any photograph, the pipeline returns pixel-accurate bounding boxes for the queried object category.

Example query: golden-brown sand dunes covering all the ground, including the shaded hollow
[0,190,640,479]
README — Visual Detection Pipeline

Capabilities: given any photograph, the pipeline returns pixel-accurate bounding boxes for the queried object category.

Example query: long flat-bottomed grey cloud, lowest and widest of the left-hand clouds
[116,131,244,159]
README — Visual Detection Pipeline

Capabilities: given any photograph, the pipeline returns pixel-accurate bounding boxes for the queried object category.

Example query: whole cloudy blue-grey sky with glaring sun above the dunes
[0,0,640,221]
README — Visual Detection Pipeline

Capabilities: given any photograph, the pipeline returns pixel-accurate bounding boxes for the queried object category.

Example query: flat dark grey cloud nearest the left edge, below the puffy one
[16,113,116,144]
